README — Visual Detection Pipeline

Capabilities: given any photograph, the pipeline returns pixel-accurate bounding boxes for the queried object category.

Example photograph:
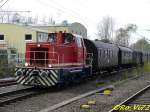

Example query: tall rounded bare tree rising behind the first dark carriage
[97,16,114,40]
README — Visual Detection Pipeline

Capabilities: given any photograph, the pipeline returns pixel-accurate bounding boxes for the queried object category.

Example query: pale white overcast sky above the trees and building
[0,0,150,42]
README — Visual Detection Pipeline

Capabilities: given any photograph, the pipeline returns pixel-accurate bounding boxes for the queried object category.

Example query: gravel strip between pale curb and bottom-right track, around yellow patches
[50,74,150,112]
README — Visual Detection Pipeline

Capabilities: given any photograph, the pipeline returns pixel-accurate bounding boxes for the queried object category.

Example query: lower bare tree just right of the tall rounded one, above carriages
[115,24,137,46]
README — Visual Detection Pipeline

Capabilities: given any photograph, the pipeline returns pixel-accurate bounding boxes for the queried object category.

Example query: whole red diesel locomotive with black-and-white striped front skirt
[15,32,92,87]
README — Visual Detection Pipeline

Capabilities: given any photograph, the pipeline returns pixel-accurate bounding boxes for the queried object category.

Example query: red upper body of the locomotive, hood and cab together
[25,32,86,67]
